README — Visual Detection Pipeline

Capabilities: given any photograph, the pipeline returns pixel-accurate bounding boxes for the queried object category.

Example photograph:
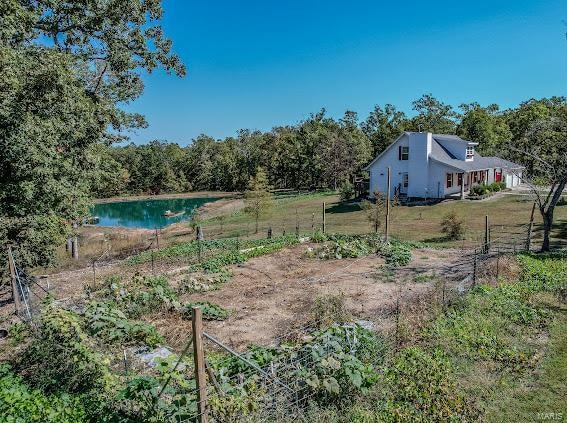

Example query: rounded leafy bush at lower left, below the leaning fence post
[15,304,112,393]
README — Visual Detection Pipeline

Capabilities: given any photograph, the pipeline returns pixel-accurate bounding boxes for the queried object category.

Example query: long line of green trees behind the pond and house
[92,94,567,197]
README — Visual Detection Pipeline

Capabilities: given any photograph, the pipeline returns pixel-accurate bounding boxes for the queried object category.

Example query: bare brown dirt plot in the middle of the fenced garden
[4,244,468,348]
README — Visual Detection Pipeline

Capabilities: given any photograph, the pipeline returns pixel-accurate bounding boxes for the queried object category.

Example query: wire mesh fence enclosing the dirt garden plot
[0,214,552,422]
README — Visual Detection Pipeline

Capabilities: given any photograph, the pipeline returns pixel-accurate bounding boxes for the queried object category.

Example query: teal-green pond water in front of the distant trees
[91,198,218,229]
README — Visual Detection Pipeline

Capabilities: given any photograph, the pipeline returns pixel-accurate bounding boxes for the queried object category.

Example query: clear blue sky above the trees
[127,0,567,145]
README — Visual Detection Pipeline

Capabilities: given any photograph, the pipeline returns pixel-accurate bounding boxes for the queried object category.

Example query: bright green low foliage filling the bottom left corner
[0,364,87,423]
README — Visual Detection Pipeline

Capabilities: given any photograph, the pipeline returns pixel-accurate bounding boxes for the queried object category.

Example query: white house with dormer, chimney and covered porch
[366,132,523,198]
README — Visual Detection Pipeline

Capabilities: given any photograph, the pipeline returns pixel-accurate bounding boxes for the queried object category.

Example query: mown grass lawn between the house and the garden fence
[204,193,567,250]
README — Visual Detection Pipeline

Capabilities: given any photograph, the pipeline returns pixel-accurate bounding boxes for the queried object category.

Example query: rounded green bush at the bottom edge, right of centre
[376,347,476,422]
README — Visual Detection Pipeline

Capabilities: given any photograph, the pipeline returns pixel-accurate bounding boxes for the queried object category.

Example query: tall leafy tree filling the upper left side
[0,0,185,266]
